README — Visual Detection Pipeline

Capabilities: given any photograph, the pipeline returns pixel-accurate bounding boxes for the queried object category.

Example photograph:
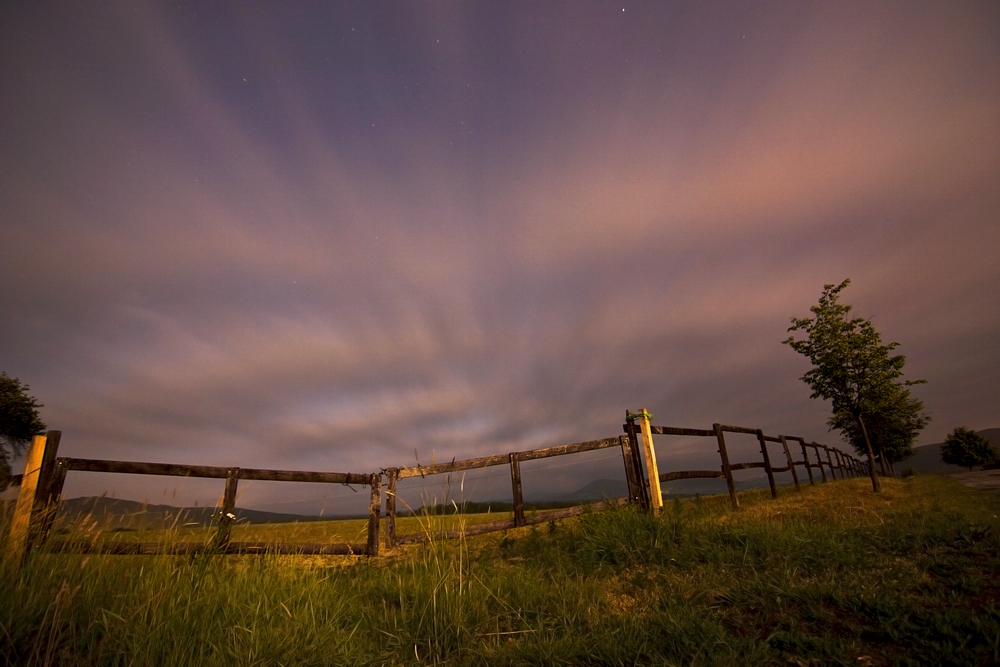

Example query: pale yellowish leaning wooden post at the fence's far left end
[8,431,62,563]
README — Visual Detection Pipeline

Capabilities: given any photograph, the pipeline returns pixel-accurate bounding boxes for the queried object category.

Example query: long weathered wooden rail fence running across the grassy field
[9,409,869,558]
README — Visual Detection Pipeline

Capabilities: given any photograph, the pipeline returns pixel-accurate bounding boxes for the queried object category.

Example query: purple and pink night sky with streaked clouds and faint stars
[0,1,1000,512]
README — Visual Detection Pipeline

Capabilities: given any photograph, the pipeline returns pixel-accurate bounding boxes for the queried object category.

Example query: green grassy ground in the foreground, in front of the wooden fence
[0,476,1000,665]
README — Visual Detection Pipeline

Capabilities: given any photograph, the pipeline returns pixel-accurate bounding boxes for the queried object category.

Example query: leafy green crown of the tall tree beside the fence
[784,280,930,470]
